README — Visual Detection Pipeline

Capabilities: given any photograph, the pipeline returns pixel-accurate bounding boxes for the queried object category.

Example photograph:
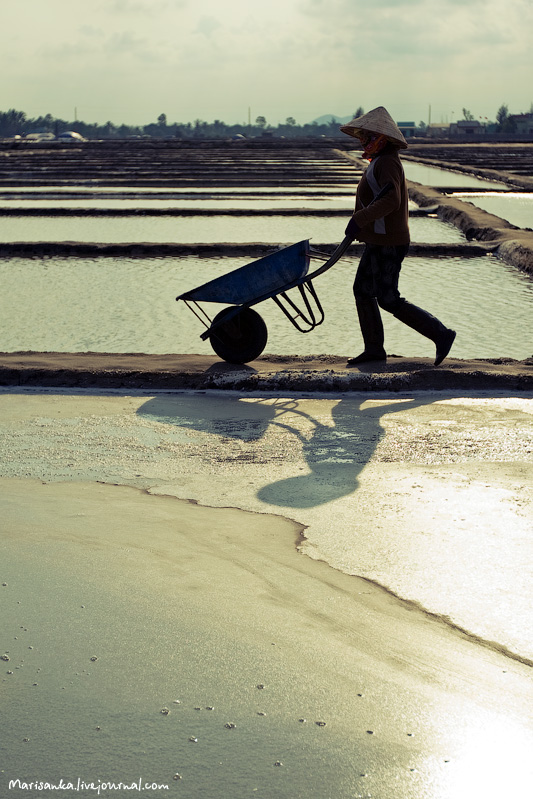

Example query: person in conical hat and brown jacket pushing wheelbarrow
[341,106,456,366]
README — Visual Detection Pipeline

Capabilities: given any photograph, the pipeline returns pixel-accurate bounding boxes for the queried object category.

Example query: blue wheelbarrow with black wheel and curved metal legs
[176,237,352,364]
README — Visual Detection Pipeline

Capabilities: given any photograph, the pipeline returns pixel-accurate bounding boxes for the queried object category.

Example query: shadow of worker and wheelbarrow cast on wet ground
[138,394,431,508]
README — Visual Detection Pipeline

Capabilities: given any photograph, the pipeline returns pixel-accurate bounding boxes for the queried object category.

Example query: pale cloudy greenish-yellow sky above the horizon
[0,0,533,126]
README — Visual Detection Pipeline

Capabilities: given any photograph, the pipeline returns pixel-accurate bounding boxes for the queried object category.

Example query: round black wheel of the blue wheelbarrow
[209,308,268,363]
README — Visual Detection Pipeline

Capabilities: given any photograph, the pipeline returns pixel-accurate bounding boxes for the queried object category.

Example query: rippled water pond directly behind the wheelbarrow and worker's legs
[0,256,533,359]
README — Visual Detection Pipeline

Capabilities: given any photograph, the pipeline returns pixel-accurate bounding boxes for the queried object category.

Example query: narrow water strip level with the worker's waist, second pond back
[0,214,465,244]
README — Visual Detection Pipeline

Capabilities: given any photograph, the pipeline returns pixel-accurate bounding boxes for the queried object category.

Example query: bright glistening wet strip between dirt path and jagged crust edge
[1,391,533,659]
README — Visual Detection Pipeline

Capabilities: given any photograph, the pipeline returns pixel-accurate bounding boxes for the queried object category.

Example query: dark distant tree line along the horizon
[0,105,533,139]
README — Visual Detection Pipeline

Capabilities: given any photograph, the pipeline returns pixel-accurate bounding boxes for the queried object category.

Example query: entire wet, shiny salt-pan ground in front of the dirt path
[0,390,533,799]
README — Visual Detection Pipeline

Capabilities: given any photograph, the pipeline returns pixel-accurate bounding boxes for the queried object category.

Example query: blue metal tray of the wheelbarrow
[176,239,311,307]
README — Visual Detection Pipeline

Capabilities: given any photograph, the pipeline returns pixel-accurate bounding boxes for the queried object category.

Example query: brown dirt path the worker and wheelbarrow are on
[0,352,533,392]
